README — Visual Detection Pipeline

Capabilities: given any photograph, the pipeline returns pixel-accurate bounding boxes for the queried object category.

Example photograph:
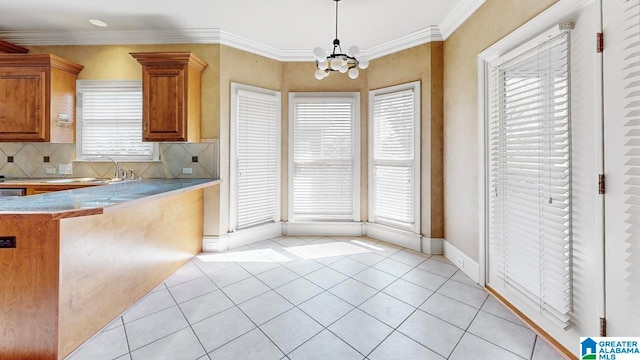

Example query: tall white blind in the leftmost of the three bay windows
[232,84,280,230]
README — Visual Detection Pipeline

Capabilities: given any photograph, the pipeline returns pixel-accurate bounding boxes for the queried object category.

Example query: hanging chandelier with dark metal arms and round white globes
[313,0,369,80]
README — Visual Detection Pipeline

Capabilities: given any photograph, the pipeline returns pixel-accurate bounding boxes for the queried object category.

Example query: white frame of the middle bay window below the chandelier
[287,92,361,222]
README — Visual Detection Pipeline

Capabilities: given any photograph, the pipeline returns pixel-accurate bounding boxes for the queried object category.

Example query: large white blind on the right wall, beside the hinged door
[489,33,573,326]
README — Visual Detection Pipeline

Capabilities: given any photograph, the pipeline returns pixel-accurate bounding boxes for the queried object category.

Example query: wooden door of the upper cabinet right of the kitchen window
[143,67,186,141]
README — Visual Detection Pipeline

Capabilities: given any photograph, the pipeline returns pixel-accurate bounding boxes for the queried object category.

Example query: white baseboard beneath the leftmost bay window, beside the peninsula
[202,222,282,252]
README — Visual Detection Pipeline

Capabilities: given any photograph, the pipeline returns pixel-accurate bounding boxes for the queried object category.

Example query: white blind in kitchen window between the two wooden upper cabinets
[77,80,156,160]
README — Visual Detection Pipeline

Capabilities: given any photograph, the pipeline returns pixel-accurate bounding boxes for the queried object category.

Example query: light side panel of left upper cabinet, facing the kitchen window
[49,69,78,144]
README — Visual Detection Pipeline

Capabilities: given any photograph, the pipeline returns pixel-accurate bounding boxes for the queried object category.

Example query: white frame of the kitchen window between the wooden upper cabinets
[75,80,160,163]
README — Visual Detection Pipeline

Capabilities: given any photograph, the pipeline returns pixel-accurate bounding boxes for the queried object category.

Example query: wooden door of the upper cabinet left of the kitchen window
[0,68,46,141]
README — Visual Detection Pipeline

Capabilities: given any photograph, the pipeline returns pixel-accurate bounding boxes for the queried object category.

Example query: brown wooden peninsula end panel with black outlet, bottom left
[0,219,59,360]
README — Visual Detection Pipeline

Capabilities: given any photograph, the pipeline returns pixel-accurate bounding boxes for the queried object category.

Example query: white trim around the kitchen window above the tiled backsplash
[74,80,160,163]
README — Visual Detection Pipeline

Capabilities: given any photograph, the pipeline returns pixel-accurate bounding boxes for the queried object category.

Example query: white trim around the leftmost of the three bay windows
[229,82,282,232]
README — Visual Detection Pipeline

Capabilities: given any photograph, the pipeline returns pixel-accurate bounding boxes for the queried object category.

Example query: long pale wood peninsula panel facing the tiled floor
[59,190,203,357]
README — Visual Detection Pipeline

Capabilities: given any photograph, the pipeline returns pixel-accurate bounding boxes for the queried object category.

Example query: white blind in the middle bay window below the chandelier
[289,93,360,221]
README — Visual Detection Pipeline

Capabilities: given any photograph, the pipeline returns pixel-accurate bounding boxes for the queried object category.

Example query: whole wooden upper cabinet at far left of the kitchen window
[0,54,83,143]
